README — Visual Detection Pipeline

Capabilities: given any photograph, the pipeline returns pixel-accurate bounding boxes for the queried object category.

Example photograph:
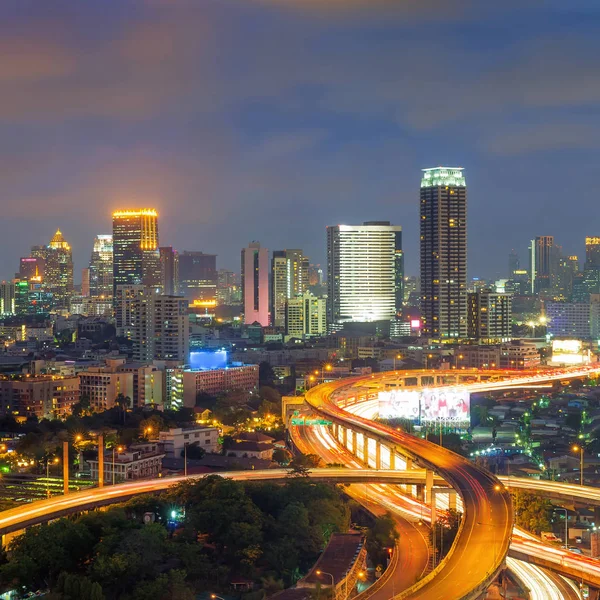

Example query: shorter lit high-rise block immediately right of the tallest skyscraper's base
[468,289,512,344]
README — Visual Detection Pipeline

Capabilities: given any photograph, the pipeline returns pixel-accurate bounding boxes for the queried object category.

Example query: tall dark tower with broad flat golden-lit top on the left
[113,208,161,296]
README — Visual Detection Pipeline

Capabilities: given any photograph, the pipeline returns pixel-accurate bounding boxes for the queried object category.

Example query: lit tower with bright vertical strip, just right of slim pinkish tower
[271,250,309,327]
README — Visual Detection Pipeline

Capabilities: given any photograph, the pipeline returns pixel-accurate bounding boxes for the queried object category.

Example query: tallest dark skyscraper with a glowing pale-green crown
[420,167,467,340]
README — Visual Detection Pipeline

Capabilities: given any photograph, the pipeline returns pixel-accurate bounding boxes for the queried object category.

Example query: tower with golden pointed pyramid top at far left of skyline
[41,229,73,308]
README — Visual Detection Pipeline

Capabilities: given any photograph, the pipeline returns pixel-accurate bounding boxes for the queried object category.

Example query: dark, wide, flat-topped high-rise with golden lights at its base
[179,250,218,305]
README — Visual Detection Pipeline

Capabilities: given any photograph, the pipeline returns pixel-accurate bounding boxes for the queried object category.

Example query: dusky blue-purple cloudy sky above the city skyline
[0,0,600,281]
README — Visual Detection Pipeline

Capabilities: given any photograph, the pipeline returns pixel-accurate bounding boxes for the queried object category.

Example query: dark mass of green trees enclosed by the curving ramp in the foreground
[0,475,350,600]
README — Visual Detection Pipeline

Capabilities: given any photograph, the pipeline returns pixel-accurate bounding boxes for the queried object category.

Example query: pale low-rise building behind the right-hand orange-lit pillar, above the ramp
[87,442,165,483]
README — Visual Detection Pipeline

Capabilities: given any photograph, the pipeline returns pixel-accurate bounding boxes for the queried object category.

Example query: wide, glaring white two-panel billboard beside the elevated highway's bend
[378,387,470,423]
